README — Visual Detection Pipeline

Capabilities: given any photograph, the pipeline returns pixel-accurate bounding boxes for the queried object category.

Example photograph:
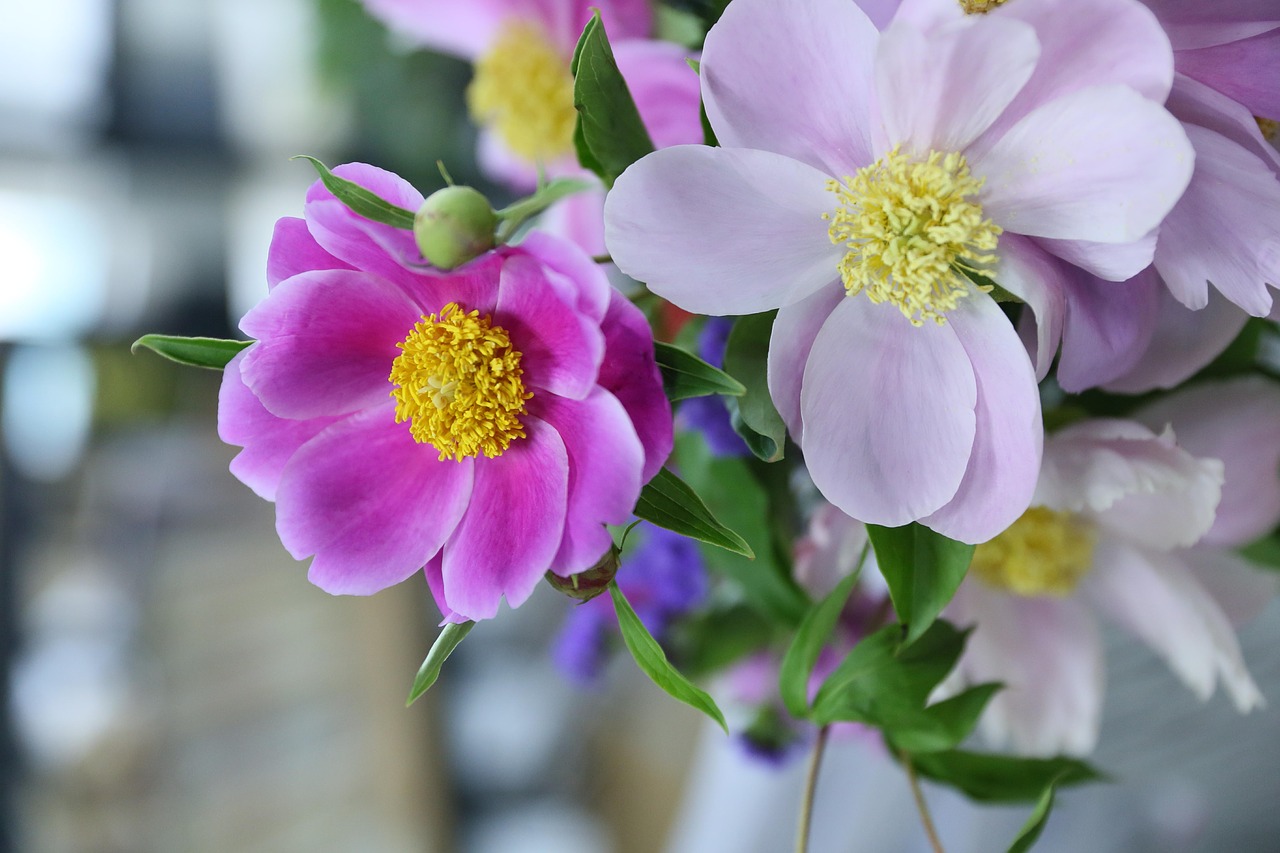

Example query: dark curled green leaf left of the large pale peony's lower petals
[724,311,787,462]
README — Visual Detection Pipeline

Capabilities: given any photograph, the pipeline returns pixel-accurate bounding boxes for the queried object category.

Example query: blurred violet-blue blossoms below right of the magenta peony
[552,523,707,684]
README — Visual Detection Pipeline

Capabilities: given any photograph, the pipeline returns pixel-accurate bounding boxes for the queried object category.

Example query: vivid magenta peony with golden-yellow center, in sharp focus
[219,164,672,620]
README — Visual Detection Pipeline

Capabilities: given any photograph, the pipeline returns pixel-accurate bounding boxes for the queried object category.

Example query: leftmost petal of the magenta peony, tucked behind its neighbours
[218,352,337,501]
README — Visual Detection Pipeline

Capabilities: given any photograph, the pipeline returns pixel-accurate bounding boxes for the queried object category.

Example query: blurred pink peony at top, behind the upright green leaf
[355,0,703,254]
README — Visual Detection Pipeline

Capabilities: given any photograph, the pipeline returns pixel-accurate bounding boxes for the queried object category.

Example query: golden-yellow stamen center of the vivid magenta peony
[390,302,534,461]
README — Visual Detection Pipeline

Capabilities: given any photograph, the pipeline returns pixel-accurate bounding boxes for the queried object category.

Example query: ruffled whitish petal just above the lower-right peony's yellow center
[1034,419,1222,551]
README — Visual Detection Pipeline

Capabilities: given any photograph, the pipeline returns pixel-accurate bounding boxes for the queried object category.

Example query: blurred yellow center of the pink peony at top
[467,22,577,163]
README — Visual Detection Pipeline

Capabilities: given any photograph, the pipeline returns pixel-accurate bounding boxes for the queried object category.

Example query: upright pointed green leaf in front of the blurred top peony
[570,12,653,187]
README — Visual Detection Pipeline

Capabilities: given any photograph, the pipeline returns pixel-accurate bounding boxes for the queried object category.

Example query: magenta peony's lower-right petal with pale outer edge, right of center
[529,388,644,575]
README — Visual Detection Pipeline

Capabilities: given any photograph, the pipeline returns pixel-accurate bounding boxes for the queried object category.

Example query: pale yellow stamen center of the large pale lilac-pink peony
[823,147,1002,325]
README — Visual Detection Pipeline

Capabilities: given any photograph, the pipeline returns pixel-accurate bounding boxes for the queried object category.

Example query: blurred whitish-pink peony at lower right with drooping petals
[945,379,1280,754]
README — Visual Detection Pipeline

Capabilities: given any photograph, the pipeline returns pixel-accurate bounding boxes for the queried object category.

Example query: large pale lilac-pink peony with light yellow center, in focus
[605,0,1193,542]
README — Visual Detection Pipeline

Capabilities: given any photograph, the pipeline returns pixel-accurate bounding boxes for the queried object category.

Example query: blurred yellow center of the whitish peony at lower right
[969,506,1094,598]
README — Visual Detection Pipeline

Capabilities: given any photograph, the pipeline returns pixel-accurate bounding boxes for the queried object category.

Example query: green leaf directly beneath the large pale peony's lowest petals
[867,521,973,643]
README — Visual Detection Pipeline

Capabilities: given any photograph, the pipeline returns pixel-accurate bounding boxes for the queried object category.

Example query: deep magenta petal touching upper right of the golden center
[494,255,604,400]
